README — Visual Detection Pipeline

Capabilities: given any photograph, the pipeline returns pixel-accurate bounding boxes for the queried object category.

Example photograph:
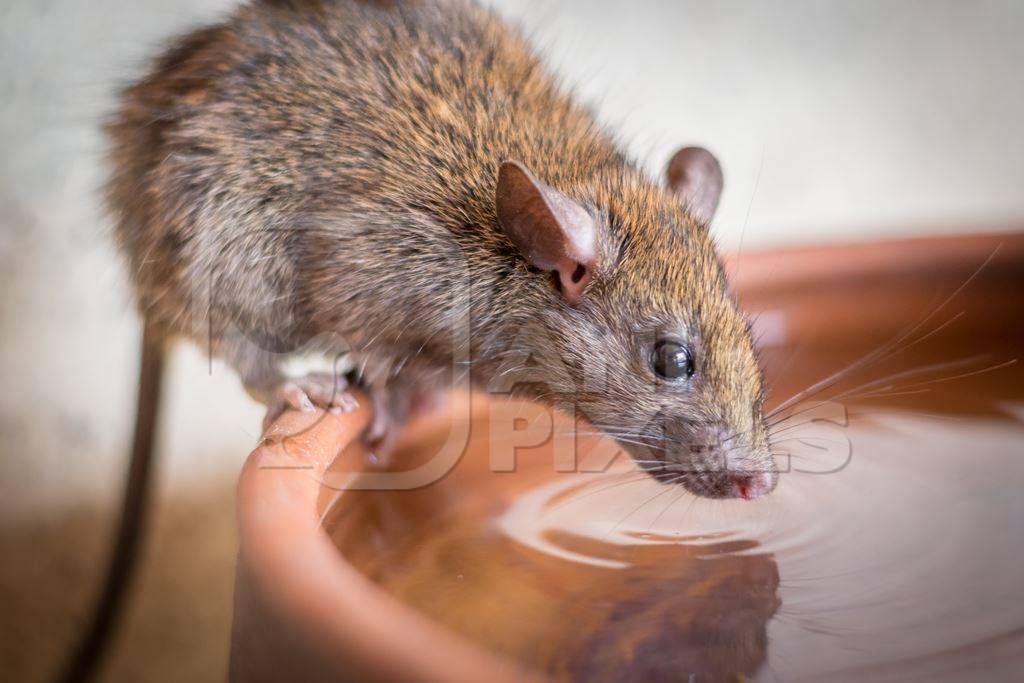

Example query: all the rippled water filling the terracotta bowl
[328,325,1024,681]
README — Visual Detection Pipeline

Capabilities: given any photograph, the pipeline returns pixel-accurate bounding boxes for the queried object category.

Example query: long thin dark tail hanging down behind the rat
[57,321,165,683]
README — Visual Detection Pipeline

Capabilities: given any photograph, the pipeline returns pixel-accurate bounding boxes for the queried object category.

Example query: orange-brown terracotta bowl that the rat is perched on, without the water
[229,234,1024,683]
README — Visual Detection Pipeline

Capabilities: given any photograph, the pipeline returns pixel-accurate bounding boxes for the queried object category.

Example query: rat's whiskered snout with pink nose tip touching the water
[666,425,778,501]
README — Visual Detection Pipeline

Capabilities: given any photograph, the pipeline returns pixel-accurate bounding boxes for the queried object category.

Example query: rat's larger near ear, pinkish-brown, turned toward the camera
[495,162,597,304]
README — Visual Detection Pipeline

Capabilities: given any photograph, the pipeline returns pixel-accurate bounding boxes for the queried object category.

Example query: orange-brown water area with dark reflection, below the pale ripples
[342,489,779,681]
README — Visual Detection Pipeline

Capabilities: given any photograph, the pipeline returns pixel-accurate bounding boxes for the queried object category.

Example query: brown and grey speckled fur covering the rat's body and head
[109,0,768,495]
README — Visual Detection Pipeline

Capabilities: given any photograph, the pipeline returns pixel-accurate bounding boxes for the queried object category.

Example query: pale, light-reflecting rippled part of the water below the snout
[507,415,1024,680]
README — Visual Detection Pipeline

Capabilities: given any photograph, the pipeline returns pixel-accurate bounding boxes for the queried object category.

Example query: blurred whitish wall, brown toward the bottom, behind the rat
[0,0,1024,681]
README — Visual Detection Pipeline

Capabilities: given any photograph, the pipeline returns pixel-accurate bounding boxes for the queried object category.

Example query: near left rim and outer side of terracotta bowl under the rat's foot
[228,395,543,683]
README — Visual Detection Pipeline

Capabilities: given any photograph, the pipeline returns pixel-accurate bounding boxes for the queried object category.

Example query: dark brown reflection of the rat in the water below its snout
[541,540,779,681]
